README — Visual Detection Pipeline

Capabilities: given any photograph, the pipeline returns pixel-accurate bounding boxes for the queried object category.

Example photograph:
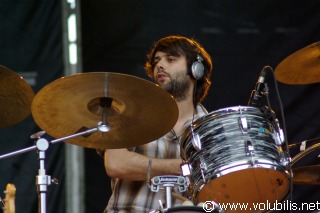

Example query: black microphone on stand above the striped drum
[248,66,269,107]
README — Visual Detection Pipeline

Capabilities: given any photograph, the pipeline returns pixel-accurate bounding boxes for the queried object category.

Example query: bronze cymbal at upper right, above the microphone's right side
[275,42,320,84]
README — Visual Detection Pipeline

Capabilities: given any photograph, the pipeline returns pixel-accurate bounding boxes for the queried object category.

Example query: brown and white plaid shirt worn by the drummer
[104,104,208,213]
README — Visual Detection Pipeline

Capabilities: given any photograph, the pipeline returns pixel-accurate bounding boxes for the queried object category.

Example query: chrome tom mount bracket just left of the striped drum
[150,175,189,208]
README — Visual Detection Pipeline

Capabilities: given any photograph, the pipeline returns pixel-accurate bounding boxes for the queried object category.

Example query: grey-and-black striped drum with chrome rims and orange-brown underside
[181,106,290,212]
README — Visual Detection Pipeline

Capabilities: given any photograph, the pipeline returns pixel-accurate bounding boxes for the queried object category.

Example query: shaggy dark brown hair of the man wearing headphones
[144,35,212,104]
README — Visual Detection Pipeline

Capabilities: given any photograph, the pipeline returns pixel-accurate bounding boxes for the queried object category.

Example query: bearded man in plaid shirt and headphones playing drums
[104,36,212,212]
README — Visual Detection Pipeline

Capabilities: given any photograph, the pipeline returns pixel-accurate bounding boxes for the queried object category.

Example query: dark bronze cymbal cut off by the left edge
[0,65,34,128]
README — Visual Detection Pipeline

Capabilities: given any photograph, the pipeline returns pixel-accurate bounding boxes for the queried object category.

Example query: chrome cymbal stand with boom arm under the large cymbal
[0,122,110,213]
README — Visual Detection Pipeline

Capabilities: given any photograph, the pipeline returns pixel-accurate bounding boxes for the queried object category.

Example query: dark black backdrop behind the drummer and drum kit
[0,0,320,213]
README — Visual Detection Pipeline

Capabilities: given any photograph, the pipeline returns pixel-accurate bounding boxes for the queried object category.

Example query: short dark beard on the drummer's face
[162,73,190,101]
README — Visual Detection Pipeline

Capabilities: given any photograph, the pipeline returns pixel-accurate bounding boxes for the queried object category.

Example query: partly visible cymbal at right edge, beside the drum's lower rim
[292,165,320,185]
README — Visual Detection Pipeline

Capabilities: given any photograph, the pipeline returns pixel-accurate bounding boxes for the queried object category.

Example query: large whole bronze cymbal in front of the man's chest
[31,72,178,149]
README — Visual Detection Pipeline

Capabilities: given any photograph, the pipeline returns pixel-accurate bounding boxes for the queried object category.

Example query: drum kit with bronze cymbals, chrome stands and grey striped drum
[0,42,320,213]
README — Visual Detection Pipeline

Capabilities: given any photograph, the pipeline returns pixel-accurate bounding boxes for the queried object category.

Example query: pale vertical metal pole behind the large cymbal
[61,0,85,213]
